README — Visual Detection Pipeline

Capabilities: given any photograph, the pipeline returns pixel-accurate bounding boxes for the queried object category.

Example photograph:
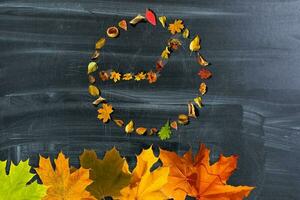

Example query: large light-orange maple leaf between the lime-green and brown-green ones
[35,152,95,200]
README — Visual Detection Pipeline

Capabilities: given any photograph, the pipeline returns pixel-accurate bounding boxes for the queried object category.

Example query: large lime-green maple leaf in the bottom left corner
[0,160,46,200]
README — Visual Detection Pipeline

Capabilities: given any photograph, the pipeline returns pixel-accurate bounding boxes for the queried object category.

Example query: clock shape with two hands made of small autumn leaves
[87,9,212,140]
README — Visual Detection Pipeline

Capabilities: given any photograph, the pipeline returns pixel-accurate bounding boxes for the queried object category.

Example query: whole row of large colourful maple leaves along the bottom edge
[0,144,254,200]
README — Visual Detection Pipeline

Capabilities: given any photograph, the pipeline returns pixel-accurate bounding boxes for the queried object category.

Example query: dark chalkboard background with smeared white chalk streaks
[0,0,300,200]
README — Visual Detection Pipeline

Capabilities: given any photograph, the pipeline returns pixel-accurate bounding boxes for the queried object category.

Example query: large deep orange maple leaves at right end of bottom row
[160,145,254,200]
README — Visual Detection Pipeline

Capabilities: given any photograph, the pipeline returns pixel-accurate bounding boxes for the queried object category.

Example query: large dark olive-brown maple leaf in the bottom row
[79,148,131,199]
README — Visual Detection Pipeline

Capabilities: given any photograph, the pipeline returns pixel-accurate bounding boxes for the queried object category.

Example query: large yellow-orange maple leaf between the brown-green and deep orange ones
[120,147,169,200]
